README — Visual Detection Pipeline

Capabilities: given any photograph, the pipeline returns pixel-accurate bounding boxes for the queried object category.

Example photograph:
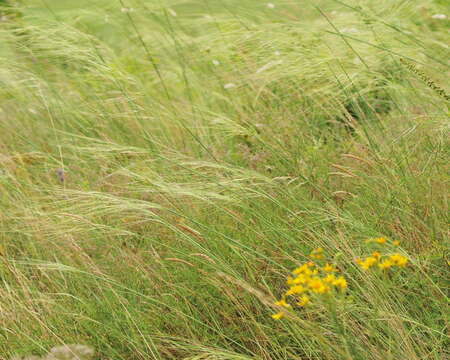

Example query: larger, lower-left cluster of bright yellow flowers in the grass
[272,248,347,320]
